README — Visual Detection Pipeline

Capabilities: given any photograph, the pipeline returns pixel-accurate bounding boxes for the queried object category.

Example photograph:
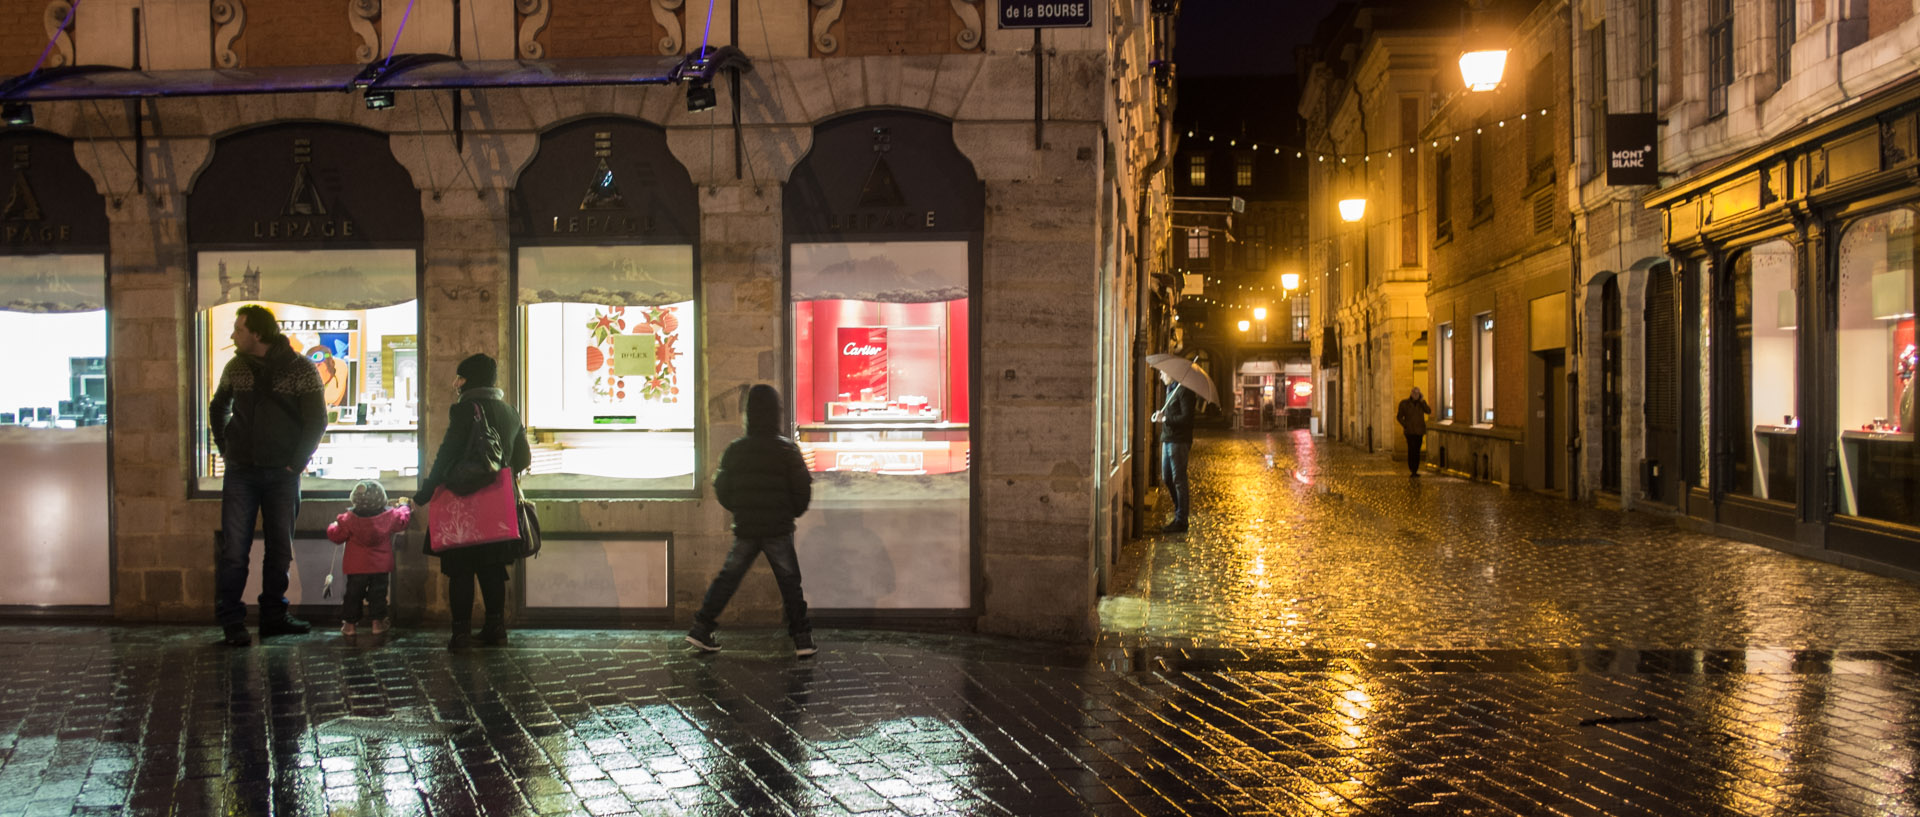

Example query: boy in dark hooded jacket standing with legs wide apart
[687,384,816,658]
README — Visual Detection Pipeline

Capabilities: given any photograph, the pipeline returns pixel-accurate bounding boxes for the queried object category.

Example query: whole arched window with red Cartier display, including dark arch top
[785,111,985,610]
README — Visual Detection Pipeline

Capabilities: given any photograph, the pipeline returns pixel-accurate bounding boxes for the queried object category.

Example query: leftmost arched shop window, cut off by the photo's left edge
[0,130,113,606]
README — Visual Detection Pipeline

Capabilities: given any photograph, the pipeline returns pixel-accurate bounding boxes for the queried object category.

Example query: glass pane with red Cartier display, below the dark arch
[791,242,972,608]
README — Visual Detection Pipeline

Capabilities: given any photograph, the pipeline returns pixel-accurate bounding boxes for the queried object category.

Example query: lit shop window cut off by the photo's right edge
[1836,209,1920,525]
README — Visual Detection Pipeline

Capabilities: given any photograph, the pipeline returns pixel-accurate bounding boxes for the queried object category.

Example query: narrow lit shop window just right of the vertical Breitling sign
[1726,242,1799,502]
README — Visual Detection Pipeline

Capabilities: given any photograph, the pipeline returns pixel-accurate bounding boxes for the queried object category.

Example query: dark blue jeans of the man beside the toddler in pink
[213,462,300,625]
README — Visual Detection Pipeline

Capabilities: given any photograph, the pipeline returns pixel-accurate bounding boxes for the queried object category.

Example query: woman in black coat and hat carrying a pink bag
[413,355,534,650]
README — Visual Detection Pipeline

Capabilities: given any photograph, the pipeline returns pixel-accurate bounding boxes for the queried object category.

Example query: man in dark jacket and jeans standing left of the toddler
[207,305,326,646]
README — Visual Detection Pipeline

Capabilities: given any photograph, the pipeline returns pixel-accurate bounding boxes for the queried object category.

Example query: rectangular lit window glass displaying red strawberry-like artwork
[516,244,699,495]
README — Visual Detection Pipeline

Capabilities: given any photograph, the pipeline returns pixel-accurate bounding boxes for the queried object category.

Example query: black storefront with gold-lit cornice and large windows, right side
[1649,81,1920,570]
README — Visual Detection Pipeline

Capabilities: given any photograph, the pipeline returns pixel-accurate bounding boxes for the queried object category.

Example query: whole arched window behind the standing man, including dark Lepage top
[186,123,422,493]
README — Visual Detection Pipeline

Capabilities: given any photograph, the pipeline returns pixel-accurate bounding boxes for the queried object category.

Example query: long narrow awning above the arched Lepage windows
[0,48,751,102]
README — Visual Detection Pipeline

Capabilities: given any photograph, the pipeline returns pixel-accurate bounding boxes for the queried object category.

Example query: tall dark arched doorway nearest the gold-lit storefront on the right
[1642,265,1680,504]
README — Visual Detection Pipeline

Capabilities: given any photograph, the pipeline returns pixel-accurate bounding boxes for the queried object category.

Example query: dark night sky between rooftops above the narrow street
[1173,0,1338,77]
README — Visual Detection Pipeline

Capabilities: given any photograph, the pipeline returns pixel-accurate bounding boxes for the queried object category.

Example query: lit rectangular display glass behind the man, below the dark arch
[196,249,420,493]
